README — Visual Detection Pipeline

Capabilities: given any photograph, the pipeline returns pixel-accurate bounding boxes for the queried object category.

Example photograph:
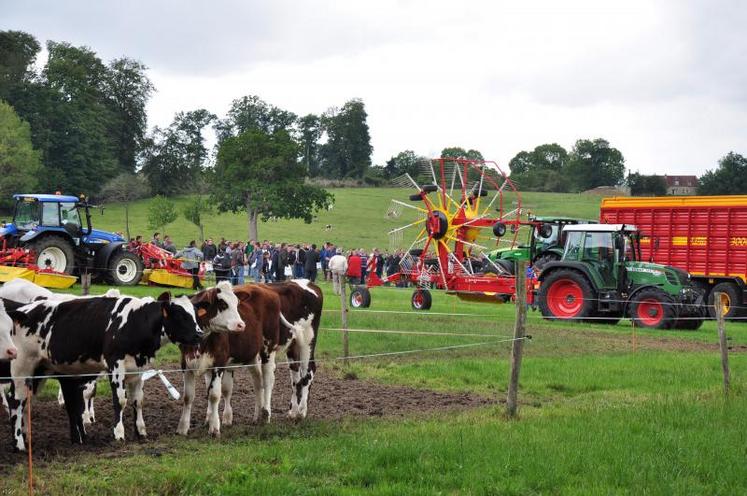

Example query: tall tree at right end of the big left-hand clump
[104,57,154,173]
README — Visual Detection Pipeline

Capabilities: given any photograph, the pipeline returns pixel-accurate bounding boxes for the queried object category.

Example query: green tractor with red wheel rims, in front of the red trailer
[535,224,705,329]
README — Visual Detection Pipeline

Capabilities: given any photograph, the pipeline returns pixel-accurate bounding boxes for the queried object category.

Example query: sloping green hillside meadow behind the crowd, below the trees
[93,188,600,249]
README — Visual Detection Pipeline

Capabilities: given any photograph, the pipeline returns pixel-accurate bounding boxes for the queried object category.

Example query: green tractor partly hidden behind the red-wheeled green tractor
[488,216,594,273]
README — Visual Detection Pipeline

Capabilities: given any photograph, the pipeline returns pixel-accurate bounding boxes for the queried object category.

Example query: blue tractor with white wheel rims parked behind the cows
[0,194,143,286]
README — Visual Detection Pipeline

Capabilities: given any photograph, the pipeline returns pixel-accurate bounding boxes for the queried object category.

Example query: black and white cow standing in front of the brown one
[8,293,203,450]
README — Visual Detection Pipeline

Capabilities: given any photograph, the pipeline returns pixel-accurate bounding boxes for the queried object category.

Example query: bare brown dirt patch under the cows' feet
[0,366,494,472]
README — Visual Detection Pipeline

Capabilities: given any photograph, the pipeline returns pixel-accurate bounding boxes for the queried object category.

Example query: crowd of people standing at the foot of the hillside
[129,232,410,289]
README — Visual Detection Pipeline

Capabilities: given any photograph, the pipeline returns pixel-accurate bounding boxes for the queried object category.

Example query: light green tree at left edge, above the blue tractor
[0,100,42,208]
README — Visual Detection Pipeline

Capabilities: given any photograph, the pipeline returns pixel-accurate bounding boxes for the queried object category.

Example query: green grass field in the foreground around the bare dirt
[0,284,747,495]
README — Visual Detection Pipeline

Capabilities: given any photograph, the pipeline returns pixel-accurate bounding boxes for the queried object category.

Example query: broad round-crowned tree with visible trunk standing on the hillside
[210,128,333,239]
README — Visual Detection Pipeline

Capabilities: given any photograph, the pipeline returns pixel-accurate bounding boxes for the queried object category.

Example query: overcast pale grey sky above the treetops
[0,0,747,174]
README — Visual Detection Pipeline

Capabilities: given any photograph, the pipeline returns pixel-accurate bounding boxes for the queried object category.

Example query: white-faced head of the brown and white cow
[190,281,245,332]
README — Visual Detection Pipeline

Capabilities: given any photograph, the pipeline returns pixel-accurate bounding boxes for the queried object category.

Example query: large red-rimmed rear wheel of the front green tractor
[537,269,594,320]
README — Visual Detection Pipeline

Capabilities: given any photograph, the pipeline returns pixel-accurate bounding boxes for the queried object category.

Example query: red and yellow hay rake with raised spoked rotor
[350,158,522,310]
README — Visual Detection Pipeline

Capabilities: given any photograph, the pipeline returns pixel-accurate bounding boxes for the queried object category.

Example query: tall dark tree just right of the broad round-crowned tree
[320,99,373,178]
